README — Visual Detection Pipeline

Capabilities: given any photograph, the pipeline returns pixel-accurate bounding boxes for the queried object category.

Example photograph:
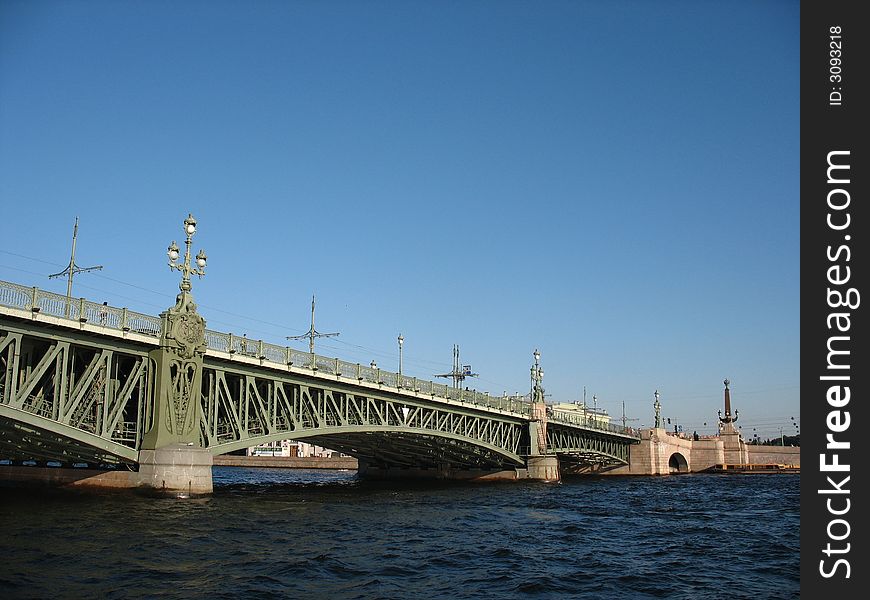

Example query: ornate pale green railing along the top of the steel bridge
[0,281,633,435]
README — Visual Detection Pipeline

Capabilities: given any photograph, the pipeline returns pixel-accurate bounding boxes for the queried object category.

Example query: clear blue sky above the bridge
[0,0,800,438]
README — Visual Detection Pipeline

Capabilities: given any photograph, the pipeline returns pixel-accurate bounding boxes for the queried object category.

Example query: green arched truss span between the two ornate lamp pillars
[201,361,527,465]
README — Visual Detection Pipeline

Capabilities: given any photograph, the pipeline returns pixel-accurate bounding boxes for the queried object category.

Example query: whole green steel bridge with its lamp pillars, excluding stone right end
[0,218,639,493]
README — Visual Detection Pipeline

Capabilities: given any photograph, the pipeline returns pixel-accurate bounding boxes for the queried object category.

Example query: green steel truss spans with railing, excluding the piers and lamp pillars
[0,281,639,471]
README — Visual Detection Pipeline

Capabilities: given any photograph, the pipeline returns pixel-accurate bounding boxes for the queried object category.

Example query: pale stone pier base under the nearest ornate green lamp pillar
[139,444,214,498]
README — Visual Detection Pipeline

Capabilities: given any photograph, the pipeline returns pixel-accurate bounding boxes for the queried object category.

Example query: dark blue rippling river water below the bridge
[0,467,800,599]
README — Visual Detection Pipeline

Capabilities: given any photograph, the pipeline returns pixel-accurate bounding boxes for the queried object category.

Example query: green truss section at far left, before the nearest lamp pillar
[0,321,151,464]
